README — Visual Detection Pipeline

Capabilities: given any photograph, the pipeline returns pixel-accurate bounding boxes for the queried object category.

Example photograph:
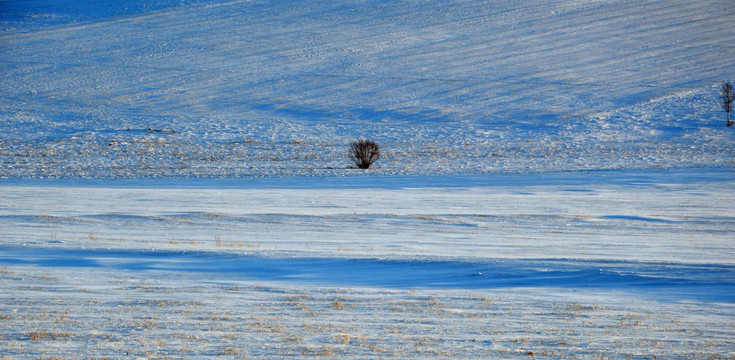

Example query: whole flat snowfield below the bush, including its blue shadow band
[0,170,735,359]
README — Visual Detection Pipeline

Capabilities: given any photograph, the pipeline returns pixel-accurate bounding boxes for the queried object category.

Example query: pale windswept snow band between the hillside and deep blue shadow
[0,171,735,265]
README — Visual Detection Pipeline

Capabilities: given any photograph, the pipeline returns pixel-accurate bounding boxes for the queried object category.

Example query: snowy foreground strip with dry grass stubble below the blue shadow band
[0,276,734,359]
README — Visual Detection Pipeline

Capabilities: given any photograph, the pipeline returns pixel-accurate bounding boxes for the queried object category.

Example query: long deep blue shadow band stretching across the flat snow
[0,248,735,303]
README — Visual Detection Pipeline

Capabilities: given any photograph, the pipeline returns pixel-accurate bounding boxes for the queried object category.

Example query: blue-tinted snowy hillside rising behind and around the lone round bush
[0,0,735,178]
